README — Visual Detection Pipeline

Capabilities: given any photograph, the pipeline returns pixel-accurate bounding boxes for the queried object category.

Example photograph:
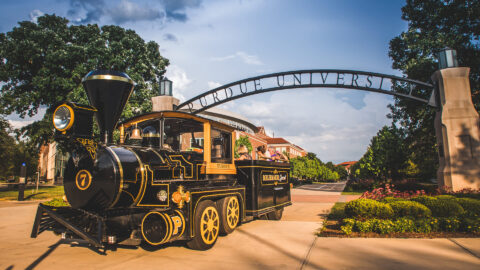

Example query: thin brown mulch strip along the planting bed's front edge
[317,220,480,238]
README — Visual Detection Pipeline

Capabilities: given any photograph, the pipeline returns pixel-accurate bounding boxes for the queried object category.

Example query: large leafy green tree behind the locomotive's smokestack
[0,15,169,146]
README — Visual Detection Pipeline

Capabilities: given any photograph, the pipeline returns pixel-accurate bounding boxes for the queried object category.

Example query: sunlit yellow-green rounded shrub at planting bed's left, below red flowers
[345,199,393,219]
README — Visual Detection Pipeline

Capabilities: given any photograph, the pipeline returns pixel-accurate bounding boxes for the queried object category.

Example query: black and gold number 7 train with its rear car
[32,71,291,250]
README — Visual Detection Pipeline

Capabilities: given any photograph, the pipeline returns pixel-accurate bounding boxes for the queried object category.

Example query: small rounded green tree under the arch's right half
[353,125,408,181]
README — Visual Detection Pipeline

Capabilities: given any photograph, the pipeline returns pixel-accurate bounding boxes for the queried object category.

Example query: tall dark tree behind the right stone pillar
[389,0,480,181]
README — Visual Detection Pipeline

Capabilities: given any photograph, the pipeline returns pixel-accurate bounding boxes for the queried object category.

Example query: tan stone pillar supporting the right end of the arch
[432,67,480,191]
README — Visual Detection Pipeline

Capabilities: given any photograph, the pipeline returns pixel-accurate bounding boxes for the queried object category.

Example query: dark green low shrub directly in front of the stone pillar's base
[412,196,464,217]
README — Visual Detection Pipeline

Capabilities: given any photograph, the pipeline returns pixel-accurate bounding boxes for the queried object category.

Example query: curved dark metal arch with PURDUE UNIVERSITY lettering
[174,69,437,114]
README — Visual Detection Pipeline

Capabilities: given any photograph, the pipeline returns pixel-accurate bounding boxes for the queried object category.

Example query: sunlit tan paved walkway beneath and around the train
[0,182,480,270]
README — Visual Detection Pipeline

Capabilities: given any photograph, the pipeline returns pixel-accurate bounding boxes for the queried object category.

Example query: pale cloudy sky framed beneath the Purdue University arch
[236,89,391,163]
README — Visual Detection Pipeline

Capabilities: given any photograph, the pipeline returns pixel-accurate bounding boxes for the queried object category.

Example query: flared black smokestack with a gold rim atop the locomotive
[82,70,135,144]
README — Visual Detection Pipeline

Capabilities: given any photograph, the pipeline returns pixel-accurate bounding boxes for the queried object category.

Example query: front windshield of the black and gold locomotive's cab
[162,118,203,153]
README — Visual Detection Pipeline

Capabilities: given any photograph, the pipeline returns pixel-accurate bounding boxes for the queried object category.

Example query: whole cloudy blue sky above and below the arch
[0,0,407,162]
